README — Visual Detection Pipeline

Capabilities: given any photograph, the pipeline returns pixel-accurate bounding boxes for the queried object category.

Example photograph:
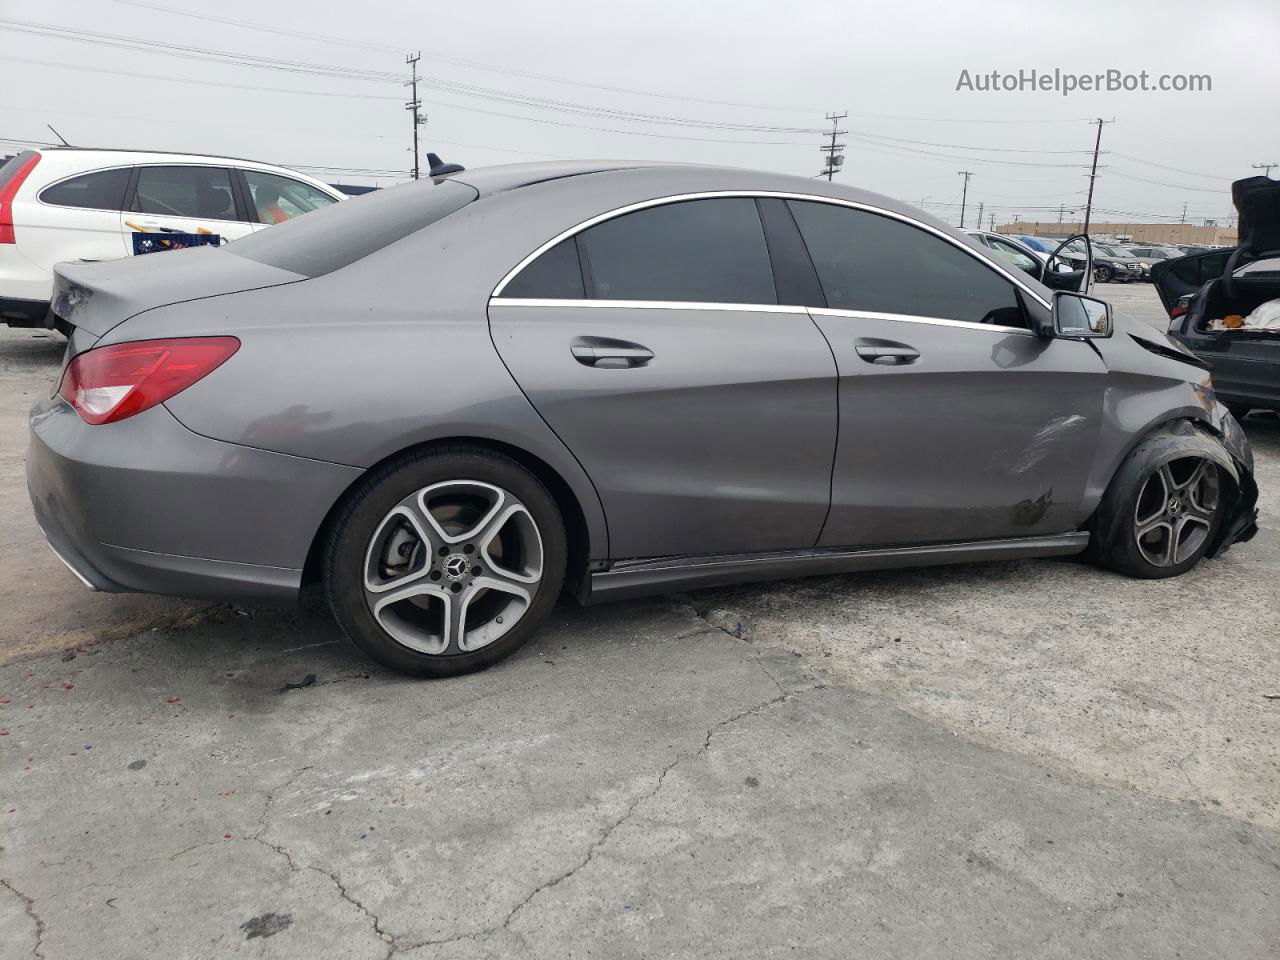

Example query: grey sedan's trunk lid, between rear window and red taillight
[52,247,306,338]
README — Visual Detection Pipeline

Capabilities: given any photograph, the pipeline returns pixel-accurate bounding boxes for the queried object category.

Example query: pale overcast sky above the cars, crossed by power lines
[0,0,1280,224]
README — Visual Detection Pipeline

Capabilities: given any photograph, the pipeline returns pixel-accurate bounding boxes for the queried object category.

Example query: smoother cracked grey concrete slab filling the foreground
[0,600,1280,959]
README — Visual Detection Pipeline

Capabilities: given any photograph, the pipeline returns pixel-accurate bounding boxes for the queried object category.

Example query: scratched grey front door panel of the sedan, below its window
[814,315,1106,547]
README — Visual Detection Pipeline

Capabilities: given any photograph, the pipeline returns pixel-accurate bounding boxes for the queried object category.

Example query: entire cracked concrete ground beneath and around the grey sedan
[0,294,1280,960]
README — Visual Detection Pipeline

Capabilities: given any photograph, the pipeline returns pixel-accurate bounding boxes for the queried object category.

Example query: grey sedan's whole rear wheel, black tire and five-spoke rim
[325,448,567,677]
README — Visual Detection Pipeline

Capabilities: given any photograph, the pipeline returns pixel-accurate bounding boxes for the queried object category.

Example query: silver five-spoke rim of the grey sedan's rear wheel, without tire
[364,480,543,655]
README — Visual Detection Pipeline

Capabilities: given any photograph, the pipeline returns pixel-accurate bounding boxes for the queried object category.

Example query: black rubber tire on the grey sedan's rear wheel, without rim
[324,445,568,677]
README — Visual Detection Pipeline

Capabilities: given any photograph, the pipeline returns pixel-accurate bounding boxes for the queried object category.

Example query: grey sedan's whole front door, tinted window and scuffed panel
[787,200,1106,547]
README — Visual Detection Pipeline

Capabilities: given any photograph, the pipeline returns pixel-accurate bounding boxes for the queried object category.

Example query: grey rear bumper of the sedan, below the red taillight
[27,398,361,603]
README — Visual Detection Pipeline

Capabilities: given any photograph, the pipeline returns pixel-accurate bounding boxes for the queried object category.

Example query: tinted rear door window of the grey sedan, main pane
[579,197,778,303]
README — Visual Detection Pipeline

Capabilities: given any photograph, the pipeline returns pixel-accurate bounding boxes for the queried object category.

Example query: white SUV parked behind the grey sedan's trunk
[0,147,343,326]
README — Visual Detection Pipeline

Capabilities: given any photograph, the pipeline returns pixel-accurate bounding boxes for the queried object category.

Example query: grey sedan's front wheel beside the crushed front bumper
[1102,452,1225,580]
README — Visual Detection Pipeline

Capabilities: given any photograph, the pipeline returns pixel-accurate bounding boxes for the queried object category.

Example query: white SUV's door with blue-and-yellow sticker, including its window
[120,164,253,253]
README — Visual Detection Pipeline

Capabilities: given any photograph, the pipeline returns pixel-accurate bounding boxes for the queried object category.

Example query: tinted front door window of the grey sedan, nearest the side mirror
[787,201,1025,326]
